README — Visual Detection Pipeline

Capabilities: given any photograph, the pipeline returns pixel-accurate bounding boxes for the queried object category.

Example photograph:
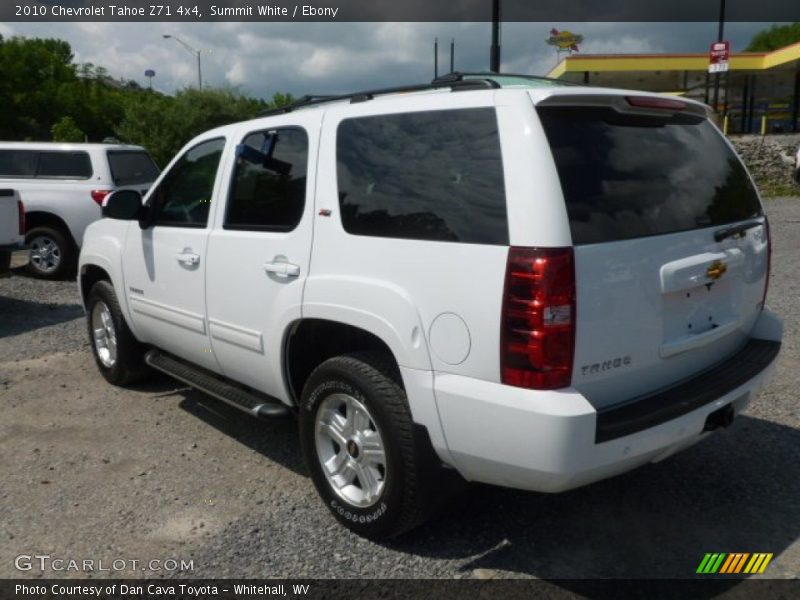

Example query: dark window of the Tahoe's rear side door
[224,127,308,231]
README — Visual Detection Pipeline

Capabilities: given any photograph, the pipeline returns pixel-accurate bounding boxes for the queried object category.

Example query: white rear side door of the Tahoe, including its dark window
[206,111,321,398]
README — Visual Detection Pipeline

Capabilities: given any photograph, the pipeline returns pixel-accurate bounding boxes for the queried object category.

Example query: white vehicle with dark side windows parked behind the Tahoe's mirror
[0,142,158,279]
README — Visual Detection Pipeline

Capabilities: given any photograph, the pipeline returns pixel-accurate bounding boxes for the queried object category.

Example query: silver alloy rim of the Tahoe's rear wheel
[316,393,386,508]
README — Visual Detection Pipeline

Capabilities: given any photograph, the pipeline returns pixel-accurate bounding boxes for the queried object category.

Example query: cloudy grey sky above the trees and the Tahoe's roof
[0,23,784,97]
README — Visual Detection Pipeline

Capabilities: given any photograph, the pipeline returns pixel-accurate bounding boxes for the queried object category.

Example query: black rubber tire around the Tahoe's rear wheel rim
[299,352,429,539]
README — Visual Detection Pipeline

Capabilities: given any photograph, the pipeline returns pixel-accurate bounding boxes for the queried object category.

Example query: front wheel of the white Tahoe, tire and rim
[87,281,147,385]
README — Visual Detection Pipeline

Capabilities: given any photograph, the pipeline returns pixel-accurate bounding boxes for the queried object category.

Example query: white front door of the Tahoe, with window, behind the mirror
[123,137,225,371]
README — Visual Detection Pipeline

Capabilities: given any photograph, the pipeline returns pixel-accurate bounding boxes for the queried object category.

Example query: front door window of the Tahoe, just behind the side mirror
[150,138,225,227]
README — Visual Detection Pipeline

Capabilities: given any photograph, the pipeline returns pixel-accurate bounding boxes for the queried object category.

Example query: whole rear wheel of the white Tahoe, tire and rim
[299,352,427,539]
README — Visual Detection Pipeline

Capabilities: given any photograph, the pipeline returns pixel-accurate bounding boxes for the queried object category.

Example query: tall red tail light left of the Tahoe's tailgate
[500,247,575,390]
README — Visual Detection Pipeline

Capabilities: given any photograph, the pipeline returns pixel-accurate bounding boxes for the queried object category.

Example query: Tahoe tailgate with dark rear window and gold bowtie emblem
[537,96,768,407]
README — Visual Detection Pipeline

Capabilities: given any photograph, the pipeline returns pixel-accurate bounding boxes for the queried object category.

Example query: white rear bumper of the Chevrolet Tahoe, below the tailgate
[435,311,780,492]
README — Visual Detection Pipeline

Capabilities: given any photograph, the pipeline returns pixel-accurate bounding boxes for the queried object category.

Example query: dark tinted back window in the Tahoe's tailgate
[538,107,761,245]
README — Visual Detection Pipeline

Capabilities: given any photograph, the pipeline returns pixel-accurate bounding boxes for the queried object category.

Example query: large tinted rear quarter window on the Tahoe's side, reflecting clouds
[337,108,508,244]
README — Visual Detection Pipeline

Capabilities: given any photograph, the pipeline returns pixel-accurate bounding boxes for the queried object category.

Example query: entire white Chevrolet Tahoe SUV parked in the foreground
[79,76,782,538]
